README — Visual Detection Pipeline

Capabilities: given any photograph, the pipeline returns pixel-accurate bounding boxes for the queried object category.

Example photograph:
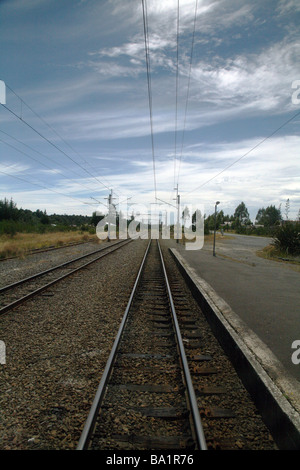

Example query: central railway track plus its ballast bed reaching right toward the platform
[77,240,276,454]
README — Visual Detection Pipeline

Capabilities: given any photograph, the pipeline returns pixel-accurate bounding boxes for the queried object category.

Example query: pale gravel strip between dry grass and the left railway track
[0,240,109,287]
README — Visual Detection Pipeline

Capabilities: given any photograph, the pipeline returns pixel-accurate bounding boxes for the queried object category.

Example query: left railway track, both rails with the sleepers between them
[0,239,131,315]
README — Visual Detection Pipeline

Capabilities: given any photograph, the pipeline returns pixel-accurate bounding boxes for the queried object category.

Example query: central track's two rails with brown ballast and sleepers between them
[77,241,207,450]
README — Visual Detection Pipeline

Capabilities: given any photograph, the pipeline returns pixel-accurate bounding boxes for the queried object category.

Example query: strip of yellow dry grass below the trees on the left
[0,231,100,258]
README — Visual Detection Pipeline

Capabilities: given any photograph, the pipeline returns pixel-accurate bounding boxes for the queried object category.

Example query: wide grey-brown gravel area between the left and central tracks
[0,240,147,450]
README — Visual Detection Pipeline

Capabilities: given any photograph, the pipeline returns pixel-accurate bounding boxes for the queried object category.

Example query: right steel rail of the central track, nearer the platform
[157,240,207,450]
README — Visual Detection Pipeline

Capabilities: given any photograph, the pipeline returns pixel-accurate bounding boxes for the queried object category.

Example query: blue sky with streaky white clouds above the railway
[0,0,300,221]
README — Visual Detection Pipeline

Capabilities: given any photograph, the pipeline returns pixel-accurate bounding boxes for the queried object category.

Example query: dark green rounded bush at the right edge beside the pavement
[273,222,300,255]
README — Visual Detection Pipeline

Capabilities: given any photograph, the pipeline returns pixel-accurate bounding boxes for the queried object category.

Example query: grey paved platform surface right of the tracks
[164,235,300,381]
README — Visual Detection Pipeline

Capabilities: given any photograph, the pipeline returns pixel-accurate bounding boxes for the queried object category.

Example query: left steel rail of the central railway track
[76,239,151,450]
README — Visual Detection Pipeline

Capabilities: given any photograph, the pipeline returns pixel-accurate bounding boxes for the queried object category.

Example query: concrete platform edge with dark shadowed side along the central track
[169,248,300,450]
